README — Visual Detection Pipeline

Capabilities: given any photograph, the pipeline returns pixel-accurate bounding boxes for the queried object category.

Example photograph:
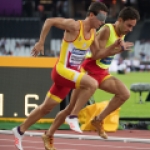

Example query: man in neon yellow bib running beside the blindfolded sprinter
[44,7,140,147]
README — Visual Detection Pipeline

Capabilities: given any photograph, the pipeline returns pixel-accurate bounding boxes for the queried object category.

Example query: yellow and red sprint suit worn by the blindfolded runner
[48,21,95,102]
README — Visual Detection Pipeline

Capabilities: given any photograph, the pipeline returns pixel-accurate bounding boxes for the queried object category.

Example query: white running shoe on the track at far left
[12,127,23,150]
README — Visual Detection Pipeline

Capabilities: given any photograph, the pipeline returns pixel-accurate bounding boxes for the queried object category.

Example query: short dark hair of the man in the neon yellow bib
[118,7,140,21]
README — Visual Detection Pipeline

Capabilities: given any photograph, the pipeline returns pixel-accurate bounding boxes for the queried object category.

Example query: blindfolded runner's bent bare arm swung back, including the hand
[31,17,80,56]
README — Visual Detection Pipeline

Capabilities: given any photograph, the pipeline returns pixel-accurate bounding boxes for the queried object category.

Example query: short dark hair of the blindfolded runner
[87,2,108,16]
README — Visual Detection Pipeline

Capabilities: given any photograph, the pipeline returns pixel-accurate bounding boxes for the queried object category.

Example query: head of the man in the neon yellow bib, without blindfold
[118,7,140,34]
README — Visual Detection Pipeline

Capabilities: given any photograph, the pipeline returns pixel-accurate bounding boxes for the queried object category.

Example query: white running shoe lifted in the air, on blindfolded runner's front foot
[65,116,82,133]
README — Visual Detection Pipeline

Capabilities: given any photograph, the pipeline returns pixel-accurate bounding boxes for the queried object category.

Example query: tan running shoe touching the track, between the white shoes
[42,133,56,150]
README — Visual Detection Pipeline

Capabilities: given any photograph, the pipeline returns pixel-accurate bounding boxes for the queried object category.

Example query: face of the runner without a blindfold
[120,19,137,35]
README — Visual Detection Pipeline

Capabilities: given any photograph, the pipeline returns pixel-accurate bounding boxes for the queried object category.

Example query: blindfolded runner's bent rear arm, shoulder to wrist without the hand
[39,17,80,44]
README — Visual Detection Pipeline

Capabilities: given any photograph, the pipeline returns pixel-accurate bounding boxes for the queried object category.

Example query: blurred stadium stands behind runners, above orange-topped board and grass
[0,0,150,72]
